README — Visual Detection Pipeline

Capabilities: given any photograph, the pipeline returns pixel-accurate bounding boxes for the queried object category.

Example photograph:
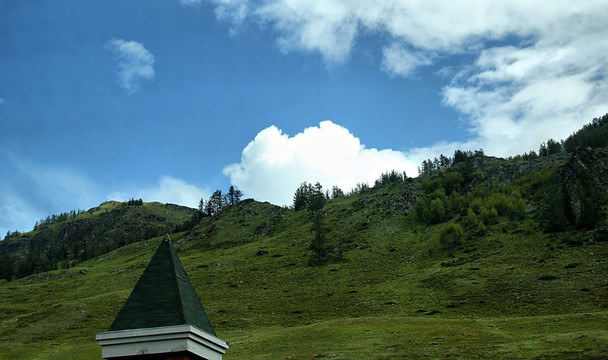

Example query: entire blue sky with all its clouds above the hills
[0,0,608,234]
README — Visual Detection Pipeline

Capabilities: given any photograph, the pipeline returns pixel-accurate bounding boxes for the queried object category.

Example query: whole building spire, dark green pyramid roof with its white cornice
[97,235,228,359]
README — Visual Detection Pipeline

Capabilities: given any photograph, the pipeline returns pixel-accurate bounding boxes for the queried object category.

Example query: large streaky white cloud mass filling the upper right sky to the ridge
[212,0,608,156]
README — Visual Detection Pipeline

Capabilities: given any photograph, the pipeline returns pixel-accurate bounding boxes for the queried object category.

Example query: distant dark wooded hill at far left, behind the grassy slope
[0,201,196,279]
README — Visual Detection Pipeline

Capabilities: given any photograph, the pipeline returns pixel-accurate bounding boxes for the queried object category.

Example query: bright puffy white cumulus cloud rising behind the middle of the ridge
[224,121,417,205]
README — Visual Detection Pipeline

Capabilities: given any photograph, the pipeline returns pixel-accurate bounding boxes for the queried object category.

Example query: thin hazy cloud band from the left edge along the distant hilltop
[0,152,211,233]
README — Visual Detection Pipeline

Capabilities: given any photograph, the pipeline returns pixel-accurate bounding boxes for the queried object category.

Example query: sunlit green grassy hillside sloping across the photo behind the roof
[0,148,608,360]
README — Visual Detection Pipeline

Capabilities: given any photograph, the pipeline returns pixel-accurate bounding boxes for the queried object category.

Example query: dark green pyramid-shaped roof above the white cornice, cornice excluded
[108,235,215,336]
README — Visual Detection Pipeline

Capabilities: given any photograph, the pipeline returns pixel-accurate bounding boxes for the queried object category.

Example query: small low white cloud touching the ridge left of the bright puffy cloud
[107,176,211,208]
